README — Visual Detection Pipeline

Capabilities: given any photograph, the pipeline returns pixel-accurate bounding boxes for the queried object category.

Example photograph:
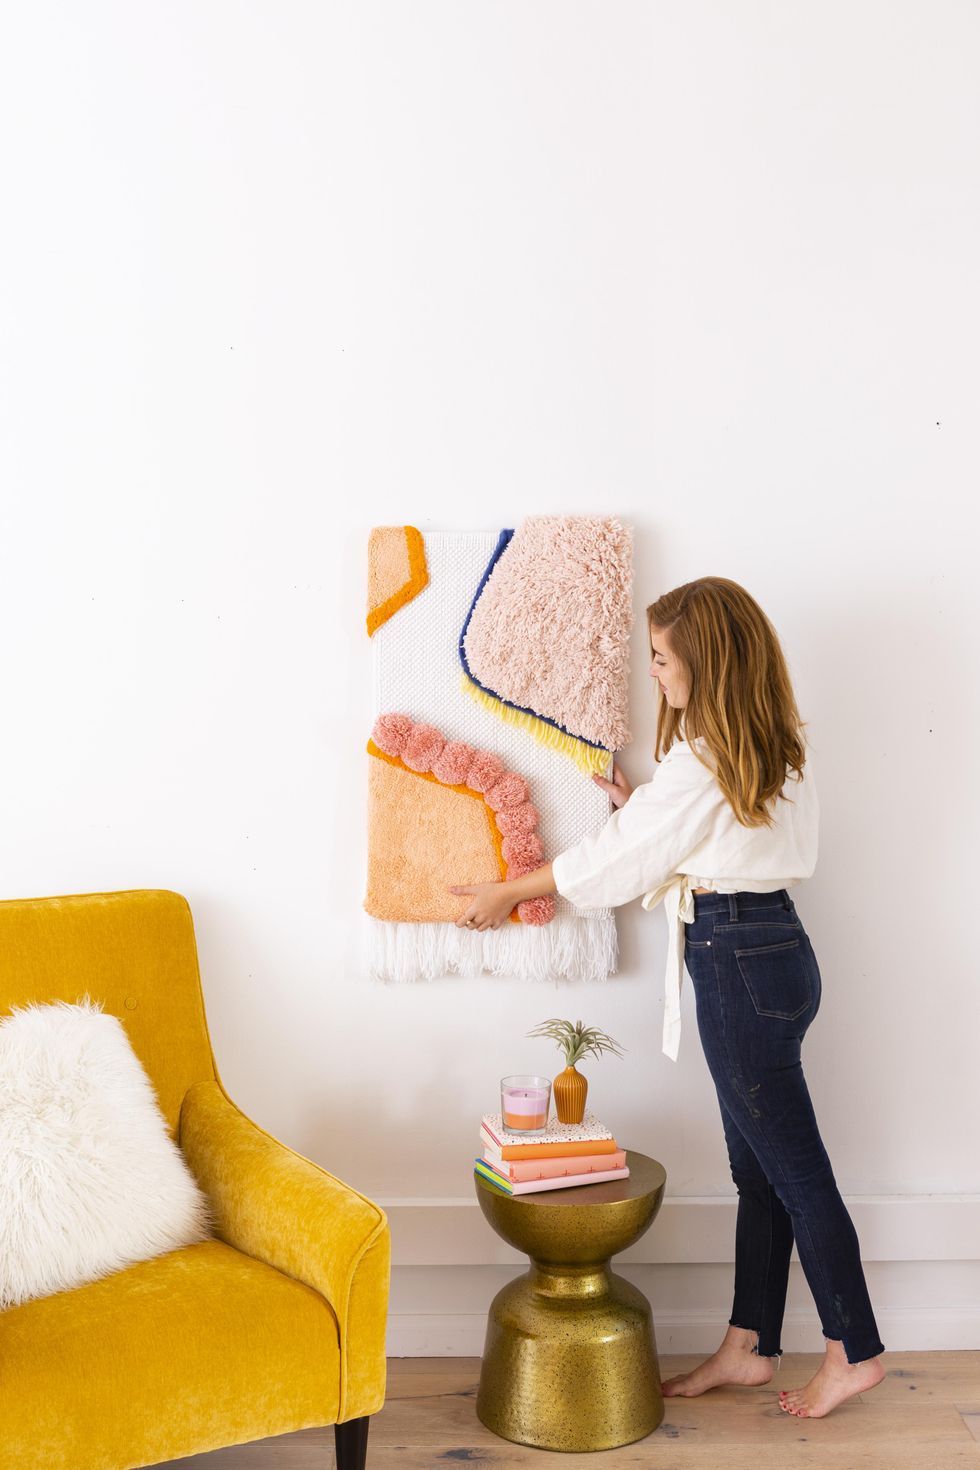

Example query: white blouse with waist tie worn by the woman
[551,736,820,1061]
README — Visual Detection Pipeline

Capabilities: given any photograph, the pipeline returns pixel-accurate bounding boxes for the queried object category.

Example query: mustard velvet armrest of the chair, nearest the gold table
[178,1080,391,1423]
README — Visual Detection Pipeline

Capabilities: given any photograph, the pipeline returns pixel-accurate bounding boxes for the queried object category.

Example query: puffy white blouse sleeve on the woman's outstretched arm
[551,745,724,908]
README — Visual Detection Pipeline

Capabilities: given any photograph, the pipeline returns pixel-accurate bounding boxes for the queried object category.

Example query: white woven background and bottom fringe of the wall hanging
[366,531,617,980]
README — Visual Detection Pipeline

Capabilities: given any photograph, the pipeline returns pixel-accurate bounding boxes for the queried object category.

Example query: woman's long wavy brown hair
[646,576,808,826]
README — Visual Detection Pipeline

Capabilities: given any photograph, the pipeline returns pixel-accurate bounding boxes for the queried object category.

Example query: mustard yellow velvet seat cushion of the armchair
[0,1241,339,1470]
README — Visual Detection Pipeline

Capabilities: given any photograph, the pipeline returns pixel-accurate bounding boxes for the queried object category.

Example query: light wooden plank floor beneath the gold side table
[153,1352,980,1470]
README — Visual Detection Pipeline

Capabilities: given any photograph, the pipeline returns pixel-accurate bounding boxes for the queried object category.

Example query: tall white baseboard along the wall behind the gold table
[376,1192,980,1357]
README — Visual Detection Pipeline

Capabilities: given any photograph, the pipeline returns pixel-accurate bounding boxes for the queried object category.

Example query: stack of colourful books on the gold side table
[476,1108,629,1194]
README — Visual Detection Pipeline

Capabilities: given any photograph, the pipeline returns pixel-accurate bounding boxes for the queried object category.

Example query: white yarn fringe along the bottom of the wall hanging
[366,910,619,980]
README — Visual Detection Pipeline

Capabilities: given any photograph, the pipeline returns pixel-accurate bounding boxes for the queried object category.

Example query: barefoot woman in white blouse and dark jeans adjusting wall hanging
[453,576,884,1419]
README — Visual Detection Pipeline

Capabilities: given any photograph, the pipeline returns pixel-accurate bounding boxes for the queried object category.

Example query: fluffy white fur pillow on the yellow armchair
[0,997,210,1310]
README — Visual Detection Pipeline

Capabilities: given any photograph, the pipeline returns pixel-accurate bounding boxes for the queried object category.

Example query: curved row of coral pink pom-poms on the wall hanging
[372,714,555,925]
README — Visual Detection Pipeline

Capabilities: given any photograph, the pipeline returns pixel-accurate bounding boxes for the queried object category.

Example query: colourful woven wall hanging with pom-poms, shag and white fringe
[364,516,632,980]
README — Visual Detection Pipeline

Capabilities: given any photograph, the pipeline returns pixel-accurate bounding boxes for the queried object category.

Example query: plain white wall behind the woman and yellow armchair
[0,0,980,1351]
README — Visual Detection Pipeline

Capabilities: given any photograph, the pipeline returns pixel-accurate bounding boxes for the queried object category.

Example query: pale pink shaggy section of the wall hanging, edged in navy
[464,516,633,750]
